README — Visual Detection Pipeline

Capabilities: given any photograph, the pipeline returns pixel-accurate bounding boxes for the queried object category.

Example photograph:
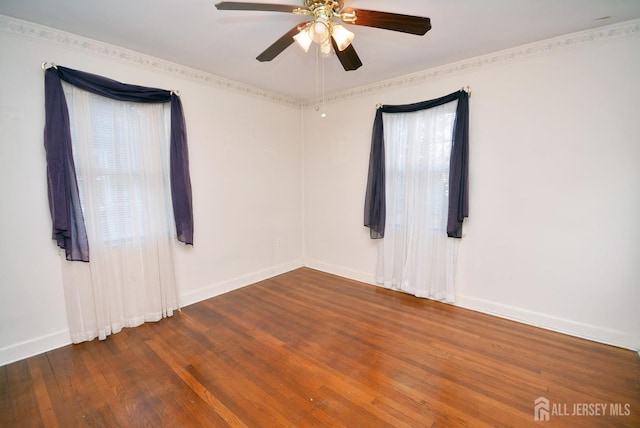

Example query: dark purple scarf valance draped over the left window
[44,66,193,262]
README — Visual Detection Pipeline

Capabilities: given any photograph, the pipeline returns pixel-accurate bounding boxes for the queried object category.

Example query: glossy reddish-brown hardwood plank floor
[0,268,640,427]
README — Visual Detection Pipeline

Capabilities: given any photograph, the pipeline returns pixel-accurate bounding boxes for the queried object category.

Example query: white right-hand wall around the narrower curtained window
[304,21,640,349]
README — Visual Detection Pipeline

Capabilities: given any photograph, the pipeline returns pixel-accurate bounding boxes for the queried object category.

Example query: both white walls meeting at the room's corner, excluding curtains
[0,16,640,365]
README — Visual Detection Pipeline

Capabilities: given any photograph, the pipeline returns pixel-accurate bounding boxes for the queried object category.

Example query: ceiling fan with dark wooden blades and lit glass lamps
[216,0,431,71]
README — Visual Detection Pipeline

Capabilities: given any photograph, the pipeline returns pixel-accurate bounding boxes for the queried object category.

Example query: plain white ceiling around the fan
[0,0,640,100]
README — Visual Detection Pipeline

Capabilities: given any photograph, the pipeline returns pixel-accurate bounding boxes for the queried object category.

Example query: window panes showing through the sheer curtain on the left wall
[64,88,172,245]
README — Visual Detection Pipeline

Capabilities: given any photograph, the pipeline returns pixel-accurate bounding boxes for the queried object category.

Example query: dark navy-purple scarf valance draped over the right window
[364,91,469,239]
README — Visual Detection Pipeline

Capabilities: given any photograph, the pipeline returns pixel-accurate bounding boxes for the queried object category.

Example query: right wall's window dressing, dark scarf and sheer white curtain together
[364,90,468,301]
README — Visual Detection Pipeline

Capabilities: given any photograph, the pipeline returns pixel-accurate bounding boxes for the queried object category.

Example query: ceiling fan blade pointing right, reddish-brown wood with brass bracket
[342,8,431,36]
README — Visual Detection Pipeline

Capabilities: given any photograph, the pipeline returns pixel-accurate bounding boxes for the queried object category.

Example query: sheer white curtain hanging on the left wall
[62,84,179,343]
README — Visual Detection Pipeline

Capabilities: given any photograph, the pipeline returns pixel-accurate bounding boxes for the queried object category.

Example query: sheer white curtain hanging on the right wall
[376,101,458,302]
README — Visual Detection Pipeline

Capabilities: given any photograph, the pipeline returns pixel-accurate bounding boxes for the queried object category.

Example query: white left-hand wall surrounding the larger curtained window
[0,16,302,365]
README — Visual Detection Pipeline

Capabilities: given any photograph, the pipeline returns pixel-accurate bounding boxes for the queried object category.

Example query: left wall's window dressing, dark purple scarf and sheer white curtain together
[44,65,193,343]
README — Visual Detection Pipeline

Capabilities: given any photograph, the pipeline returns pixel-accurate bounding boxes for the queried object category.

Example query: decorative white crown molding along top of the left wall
[0,15,302,107]
